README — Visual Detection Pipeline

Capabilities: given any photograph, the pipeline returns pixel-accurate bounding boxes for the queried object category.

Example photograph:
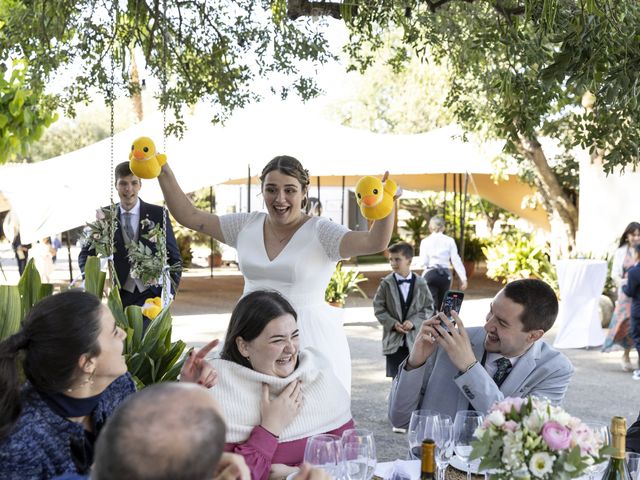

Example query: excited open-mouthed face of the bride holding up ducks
[262,170,306,225]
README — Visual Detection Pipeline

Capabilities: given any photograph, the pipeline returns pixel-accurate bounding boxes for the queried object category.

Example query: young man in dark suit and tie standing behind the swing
[78,162,182,307]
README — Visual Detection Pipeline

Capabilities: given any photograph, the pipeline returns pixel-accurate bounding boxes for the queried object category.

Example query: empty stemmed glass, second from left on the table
[342,428,377,480]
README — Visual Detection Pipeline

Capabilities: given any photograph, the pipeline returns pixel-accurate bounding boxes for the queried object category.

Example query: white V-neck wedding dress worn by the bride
[220,212,351,394]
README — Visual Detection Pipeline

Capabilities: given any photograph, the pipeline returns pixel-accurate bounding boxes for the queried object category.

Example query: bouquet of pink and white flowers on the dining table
[470,397,611,480]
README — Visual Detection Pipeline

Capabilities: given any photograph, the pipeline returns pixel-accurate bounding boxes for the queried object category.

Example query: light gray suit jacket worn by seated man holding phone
[389,327,573,428]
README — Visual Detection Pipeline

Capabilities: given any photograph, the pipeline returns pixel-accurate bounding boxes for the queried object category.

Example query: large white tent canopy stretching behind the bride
[0,103,544,243]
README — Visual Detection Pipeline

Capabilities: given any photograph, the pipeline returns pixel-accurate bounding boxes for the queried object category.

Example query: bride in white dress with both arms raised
[158,156,394,393]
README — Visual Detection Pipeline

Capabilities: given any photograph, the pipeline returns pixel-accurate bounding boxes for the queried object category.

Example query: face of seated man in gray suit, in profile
[484,290,544,357]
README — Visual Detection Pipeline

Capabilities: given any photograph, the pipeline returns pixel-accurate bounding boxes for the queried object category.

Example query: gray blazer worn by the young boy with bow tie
[373,273,433,355]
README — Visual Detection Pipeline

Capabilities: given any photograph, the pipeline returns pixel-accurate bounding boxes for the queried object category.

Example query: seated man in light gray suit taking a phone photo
[389,279,573,428]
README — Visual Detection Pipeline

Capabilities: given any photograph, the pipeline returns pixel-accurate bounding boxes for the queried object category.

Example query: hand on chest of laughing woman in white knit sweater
[260,380,303,437]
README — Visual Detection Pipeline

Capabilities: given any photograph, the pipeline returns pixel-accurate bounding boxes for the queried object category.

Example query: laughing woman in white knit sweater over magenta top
[211,290,354,479]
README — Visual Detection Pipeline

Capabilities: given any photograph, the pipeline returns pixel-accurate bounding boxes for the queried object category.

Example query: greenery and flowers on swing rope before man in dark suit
[127,218,180,286]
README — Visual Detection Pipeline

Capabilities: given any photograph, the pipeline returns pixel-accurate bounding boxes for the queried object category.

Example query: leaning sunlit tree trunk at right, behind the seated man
[516,135,578,258]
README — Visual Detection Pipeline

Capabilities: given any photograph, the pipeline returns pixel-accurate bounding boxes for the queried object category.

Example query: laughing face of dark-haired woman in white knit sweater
[236,313,300,378]
